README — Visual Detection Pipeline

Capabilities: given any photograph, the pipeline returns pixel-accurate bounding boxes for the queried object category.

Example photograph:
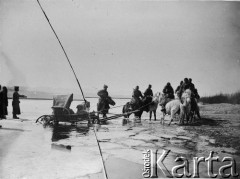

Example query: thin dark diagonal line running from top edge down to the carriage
[37,0,87,102]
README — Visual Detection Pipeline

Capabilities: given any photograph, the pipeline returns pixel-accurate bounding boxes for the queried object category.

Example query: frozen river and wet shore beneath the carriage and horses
[0,99,240,179]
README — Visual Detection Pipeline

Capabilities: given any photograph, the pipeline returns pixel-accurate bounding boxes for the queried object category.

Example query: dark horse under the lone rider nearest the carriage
[97,96,116,118]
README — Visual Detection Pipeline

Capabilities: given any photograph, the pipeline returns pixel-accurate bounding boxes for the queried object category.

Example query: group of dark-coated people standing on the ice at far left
[0,85,26,119]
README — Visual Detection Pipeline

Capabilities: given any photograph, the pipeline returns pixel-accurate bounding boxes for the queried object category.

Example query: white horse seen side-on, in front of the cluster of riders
[159,93,184,125]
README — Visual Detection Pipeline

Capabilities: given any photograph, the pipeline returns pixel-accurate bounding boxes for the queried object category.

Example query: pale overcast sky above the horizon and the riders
[0,0,240,95]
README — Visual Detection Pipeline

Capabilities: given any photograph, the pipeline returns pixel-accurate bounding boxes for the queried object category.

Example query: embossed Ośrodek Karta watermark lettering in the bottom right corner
[142,150,239,178]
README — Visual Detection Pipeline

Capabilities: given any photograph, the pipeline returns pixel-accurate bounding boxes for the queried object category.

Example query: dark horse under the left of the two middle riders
[122,97,152,119]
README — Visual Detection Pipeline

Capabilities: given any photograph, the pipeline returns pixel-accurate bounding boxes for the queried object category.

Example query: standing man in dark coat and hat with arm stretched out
[12,86,26,119]
